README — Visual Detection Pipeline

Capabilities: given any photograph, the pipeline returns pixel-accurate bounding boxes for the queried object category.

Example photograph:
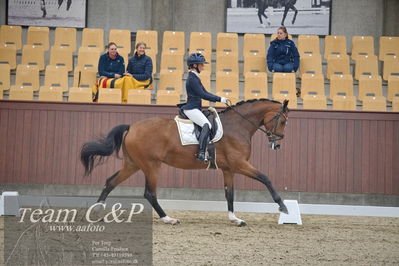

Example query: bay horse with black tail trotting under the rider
[80,99,288,226]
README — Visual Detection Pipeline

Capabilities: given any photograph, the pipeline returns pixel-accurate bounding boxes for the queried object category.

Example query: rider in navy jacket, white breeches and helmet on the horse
[178,53,227,162]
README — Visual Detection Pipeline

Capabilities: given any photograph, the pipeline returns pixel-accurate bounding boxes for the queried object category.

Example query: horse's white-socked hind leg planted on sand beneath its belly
[142,162,180,224]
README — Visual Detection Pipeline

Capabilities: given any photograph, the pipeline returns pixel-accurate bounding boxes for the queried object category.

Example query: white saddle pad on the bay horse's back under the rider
[175,107,223,145]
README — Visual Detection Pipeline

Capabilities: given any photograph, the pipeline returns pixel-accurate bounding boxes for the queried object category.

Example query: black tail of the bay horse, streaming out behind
[80,125,130,176]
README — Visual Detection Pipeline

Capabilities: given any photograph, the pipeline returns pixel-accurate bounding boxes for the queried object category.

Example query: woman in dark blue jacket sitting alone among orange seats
[267,27,299,72]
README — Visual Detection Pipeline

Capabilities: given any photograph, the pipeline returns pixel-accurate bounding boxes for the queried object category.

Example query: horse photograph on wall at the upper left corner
[7,0,87,28]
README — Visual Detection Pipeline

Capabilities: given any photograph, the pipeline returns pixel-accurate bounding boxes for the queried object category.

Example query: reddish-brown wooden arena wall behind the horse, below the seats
[0,101,399,195]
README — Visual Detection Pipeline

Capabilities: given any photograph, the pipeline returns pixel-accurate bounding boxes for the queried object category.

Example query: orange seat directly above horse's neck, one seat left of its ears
[244,72,268,100]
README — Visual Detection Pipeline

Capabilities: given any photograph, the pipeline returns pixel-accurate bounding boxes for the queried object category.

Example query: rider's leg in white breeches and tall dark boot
[184,109,212,161]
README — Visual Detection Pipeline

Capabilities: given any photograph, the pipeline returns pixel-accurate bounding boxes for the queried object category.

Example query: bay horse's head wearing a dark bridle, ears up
[263,100,288,150]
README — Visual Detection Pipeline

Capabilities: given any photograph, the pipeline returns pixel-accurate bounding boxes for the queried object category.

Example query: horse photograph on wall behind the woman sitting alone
[226,0,331,35]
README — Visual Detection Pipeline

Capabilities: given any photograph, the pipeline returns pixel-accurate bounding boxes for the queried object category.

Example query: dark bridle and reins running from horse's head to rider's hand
[226,100,288,141]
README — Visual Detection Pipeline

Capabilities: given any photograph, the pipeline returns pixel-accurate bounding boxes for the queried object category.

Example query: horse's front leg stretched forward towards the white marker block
[238,161,288,214]
